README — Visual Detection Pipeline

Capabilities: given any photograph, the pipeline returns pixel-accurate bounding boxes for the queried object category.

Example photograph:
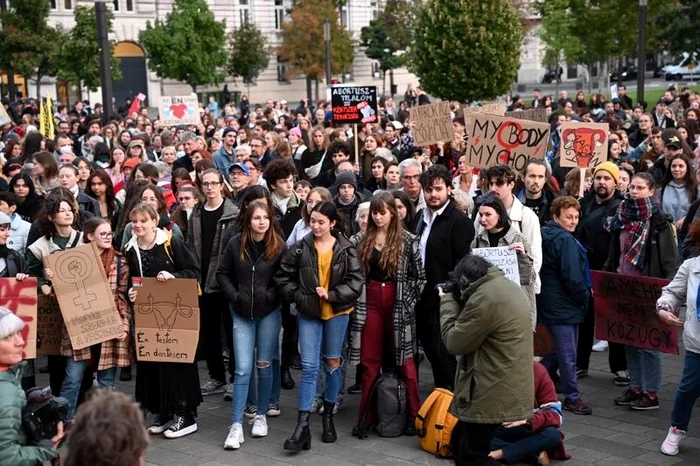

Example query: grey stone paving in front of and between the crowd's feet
[40,352,700,466]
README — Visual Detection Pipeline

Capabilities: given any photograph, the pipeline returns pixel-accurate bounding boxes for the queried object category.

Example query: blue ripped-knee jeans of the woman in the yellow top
[299,314,350,411]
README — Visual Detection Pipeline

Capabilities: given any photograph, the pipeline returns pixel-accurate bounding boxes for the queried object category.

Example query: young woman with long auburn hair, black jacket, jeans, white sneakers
[216,200,286,450]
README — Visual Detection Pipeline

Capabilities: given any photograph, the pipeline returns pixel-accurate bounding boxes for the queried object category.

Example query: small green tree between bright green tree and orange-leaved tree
[226,22,270,95]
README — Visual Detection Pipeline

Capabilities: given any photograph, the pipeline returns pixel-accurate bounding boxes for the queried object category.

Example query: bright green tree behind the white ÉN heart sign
[139,0,228,92]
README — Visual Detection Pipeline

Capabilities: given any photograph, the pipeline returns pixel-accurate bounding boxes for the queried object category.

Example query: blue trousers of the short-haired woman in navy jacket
[540,325,581,402]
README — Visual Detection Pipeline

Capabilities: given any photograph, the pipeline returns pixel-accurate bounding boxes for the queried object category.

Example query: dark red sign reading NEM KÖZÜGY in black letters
[591,271,679,354]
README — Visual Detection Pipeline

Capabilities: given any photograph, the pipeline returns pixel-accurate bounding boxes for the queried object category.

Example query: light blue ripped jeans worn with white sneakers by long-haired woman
[231,309,282,423]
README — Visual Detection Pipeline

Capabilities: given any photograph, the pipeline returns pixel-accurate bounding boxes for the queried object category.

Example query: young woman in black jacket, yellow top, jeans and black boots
[275,202,364,450]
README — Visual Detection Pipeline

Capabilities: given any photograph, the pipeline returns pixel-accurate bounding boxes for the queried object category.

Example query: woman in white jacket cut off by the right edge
[656,220,700,456]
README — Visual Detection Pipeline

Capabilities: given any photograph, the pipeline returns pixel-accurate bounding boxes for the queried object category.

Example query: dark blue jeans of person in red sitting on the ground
[491,426,561,464]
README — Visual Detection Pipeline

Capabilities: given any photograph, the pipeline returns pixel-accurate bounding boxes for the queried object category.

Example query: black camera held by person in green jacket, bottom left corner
[22,387,69,444]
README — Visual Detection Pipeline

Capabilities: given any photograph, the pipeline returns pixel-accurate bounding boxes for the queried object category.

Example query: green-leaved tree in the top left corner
[0,0,65,96]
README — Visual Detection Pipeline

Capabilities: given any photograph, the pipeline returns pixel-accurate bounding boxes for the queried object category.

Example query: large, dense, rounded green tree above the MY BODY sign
[409,0,523,102]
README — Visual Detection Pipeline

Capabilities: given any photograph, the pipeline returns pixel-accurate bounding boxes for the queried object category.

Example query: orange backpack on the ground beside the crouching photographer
[416,388,457,458]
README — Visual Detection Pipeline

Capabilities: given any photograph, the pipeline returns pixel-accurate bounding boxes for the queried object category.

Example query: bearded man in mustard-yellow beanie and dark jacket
[576,162,629,386]
